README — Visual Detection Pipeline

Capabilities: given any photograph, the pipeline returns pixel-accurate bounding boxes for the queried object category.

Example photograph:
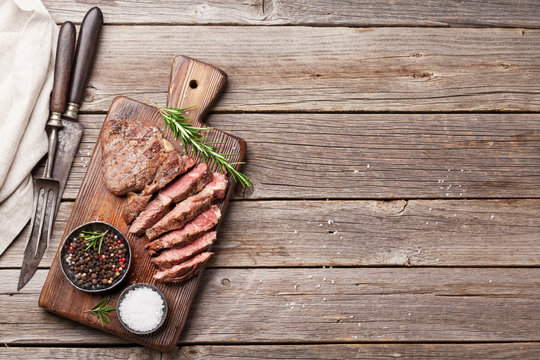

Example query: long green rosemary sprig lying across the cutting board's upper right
[146,98,251,187]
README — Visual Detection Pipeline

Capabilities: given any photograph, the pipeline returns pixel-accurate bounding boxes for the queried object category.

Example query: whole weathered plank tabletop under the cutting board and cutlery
[0,0,540,359]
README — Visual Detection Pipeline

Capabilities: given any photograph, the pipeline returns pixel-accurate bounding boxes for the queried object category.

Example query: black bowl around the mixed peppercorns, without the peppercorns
[59,221,131,293]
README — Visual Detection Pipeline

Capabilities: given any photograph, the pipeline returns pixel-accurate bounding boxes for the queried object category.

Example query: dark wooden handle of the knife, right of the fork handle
[64,7,103,117]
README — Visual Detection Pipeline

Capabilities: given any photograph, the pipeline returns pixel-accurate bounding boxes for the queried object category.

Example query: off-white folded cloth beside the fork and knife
[0,0,58,255]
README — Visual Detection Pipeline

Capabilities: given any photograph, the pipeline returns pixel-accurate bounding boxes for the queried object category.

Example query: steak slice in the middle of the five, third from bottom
[146,205,221,255]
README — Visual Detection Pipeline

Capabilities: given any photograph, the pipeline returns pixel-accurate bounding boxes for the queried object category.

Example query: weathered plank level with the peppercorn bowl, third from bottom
[0,200,540,268]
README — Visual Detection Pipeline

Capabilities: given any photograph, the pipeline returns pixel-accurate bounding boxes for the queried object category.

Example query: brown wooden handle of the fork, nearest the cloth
[51,21,75,113]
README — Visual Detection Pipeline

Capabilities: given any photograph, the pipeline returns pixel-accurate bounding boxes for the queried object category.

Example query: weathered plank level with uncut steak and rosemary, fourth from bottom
[58,114,540,199]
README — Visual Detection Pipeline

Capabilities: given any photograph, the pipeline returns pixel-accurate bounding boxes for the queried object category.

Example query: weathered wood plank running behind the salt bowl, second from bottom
[0,268,540,346]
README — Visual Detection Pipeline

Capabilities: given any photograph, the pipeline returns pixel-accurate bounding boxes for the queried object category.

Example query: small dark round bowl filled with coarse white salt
[118,287,165,332]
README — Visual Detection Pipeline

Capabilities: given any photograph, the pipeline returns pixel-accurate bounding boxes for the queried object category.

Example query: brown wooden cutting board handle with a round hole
[167,56,227,126]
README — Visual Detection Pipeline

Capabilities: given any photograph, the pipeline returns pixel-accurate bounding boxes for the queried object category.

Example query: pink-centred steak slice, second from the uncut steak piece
[146,173,227,240]
